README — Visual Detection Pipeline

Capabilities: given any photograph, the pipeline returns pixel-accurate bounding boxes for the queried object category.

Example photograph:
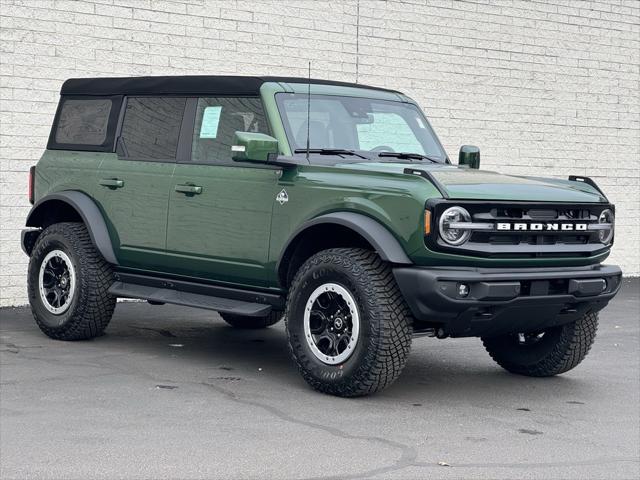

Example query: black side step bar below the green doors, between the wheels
[109,272,284,317]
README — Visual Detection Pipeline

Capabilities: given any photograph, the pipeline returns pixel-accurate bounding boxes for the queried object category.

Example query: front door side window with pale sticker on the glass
[191,97,269,164]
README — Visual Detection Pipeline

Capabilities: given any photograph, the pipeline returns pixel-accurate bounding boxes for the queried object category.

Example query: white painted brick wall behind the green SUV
[0,0,640,306]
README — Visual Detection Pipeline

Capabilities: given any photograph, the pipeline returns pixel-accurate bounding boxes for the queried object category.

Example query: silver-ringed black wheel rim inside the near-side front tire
[304,283,360,365]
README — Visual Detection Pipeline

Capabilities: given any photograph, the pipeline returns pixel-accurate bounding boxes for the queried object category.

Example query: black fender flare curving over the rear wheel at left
[22,190,118,265]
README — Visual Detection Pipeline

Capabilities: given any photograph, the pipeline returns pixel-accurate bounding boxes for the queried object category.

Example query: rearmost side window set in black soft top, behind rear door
[48,96,122,152]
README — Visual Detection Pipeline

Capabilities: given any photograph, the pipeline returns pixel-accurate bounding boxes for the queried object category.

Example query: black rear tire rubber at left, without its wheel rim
[28,222,116,340]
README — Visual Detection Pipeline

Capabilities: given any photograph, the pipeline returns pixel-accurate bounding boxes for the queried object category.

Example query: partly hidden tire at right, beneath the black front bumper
[482,312,598,377]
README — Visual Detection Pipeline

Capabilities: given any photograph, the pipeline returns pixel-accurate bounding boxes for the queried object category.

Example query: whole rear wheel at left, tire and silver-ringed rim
[27,223,116,340]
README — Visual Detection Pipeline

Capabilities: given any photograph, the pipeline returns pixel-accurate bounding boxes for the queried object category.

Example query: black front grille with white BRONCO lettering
[425,200,613,258]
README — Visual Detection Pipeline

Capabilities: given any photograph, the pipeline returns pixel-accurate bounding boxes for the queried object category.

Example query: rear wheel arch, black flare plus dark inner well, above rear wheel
[21,190,118,265]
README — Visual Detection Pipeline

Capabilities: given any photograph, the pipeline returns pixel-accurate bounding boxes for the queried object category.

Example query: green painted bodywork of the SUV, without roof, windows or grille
[35,83,608,290]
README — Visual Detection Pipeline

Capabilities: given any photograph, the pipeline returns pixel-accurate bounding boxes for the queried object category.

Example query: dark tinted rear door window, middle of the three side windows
[116,97,186,161]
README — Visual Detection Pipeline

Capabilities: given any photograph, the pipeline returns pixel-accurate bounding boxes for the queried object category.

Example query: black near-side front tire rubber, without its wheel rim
[285,248,412,397]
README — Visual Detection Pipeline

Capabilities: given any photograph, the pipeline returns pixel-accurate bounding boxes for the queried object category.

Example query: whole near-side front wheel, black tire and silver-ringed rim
[285,248,412,397]
